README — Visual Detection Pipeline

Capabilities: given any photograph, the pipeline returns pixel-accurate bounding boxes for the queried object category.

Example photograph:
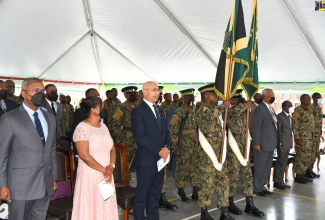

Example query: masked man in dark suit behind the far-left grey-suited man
[43,84,65,138]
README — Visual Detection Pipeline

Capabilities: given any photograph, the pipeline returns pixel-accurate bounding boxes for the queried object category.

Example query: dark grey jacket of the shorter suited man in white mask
[277,111,292,150]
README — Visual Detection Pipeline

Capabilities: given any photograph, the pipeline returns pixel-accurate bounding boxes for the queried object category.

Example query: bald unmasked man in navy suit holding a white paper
[131,81,171,220]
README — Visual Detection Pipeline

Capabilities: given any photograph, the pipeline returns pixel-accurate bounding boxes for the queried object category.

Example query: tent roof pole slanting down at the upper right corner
[283,0,325,71]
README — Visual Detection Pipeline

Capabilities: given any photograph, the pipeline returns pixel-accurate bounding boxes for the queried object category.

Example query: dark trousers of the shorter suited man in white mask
[273,149,290,184]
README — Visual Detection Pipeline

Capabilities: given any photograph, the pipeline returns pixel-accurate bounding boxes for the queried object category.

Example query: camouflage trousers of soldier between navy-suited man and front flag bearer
[175,144,199,188]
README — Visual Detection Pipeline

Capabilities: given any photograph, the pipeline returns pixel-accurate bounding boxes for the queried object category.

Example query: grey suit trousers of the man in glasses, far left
[8,195,50,220]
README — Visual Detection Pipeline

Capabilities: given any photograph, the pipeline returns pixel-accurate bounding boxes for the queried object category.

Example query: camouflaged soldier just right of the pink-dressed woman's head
[103,90,121,141]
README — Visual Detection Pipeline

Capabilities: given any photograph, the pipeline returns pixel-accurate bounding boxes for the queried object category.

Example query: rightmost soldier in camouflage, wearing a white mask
[305,92,323,179]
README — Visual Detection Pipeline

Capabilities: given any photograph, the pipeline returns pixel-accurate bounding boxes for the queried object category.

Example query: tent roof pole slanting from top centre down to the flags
[155,0,218,68]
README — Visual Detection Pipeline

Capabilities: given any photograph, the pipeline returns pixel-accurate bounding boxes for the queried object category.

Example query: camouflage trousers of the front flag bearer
[198,153,229,208]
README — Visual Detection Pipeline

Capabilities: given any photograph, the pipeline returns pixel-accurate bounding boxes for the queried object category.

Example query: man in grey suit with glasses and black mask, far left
[0,78,57,220]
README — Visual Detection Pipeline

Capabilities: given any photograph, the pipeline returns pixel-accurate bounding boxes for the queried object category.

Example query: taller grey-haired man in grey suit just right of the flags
[250,89,279,196]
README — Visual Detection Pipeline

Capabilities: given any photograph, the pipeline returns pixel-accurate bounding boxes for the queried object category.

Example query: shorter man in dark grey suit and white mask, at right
[273,101,292,189]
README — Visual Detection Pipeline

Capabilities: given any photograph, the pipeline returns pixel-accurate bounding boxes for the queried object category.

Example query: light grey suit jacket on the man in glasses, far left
[0,105,57,200]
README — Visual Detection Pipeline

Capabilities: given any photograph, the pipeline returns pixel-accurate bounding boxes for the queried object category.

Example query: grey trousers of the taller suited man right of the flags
[254,149,274,192]
